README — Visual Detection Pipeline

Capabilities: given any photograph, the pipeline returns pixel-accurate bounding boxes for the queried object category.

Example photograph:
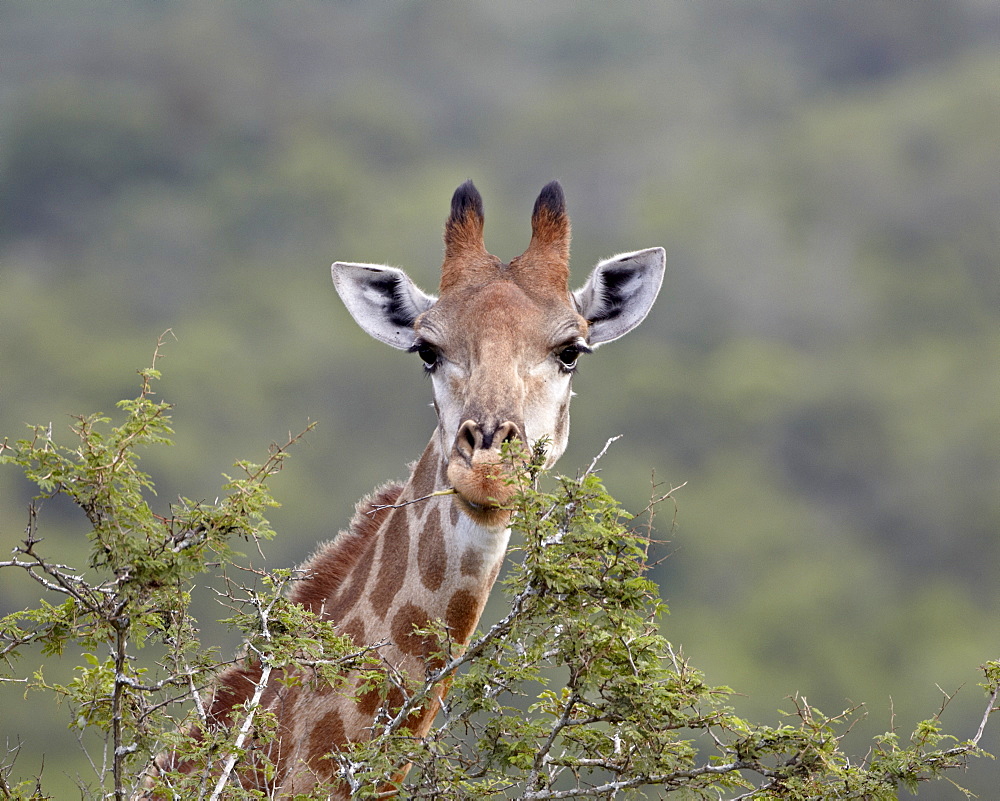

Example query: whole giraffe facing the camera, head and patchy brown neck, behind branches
[143,181,665,798]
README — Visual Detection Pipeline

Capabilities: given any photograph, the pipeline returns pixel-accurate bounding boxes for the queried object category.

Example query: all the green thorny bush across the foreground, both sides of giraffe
[0,350,1000,799]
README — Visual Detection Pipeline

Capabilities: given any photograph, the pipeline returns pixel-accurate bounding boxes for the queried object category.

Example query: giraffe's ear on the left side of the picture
[330,261,437,350]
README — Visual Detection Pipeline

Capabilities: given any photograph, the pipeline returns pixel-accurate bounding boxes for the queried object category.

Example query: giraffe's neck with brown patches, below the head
[269,432,510,797]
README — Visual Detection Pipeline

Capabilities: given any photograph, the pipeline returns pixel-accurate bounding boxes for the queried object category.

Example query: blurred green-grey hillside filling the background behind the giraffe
[0,0,1000,799]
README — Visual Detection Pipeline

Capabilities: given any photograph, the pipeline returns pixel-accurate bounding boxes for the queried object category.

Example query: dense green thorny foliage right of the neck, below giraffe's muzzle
[324,462,997,801]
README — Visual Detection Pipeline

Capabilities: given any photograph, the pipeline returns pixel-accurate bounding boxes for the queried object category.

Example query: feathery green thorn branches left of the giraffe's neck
[0,350,324,798]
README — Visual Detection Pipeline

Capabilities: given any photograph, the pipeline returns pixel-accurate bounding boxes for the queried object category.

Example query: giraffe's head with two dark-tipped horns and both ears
[332,181,664,526]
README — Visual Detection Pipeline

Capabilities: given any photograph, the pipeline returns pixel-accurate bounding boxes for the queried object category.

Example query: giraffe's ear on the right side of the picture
[573,248,666,347]
